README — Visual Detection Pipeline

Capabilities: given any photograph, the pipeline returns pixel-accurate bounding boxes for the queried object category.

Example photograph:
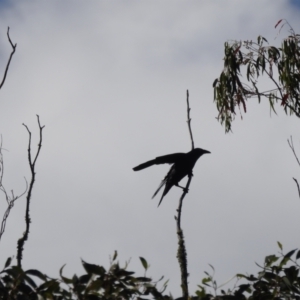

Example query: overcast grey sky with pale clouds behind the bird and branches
[0,0,300,296]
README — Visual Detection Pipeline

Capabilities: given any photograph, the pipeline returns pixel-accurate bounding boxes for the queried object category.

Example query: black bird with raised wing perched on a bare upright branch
[133,148,210,206]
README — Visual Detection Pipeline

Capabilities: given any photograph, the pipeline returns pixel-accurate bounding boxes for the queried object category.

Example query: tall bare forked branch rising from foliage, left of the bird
[17,115,45,267]
